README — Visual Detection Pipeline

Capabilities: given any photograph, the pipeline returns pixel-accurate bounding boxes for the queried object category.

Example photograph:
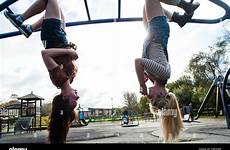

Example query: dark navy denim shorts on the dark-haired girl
[41,18,68,48]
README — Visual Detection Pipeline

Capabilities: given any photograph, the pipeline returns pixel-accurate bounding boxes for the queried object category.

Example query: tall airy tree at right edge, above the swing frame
[188,35,230,85]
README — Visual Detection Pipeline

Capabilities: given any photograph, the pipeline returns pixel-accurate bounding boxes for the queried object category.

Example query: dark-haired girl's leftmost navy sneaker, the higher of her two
[4,11,24,28]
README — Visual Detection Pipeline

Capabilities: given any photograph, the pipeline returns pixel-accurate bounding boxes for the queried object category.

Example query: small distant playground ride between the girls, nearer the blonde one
[121,112,139,127]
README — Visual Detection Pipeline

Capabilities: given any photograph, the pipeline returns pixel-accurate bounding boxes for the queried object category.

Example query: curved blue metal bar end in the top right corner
[188,0,230,24]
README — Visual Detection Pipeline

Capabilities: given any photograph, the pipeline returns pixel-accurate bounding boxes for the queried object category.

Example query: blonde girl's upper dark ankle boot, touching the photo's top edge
[178,0,200,15]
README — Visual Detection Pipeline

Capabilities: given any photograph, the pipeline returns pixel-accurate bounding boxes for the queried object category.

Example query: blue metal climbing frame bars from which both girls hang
[0,0,230,39]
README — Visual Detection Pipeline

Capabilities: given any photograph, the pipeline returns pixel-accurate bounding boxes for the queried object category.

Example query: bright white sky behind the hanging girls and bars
[0,0,230,108]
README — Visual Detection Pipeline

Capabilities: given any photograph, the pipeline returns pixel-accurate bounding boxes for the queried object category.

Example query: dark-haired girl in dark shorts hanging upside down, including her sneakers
[4,0,79,143]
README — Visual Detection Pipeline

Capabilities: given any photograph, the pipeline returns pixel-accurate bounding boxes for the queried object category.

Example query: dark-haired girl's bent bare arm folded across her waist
[41,48,78,70]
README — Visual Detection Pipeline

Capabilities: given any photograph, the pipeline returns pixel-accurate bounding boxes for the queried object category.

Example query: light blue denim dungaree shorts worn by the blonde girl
[142,16,170,59]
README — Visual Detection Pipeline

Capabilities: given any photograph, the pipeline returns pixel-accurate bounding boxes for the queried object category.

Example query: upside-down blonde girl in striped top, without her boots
[135,0,183,141]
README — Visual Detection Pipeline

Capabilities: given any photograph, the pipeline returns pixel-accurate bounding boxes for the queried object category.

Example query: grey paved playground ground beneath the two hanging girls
[0,119,230,144]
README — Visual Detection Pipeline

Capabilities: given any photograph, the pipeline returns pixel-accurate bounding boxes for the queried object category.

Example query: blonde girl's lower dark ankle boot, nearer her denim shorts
[170,12,193,28]
